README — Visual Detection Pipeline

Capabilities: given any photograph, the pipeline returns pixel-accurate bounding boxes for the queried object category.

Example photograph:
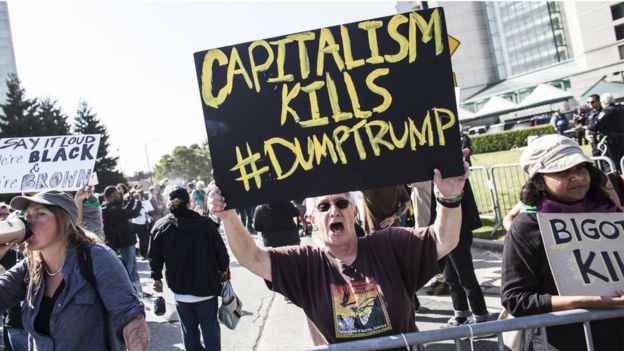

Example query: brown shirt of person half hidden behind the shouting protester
[362,185,409,234]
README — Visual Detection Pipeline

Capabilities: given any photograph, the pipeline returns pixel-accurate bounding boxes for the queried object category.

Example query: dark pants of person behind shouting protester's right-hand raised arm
[444,232,488,316]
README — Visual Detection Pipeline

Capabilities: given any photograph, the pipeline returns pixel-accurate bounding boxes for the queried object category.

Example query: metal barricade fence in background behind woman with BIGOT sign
[470,156,624,235]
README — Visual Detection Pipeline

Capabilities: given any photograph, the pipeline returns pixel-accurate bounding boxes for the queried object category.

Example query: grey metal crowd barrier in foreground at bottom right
[310,309,624,351]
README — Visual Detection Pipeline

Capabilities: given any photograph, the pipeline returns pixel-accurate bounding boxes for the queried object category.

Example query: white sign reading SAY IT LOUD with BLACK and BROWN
[0,134,100,193]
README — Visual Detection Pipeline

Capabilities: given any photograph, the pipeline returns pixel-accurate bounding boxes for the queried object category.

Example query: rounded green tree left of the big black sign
[156,144,212,182]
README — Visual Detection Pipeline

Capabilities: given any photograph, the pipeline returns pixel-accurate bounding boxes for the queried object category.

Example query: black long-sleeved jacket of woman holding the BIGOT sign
[501,213,624,350]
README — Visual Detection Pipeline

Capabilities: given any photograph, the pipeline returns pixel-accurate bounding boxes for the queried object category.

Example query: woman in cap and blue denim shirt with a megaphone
[0,190,149,350]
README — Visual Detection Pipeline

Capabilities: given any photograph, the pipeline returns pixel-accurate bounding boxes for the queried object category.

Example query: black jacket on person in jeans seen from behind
[148,210,230,296]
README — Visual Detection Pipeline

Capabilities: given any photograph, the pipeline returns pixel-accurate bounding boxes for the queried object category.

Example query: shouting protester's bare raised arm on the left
[208,183,271,281]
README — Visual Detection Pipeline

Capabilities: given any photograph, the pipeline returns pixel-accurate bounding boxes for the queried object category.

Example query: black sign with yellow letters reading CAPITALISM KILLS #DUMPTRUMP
[195,8,463,208]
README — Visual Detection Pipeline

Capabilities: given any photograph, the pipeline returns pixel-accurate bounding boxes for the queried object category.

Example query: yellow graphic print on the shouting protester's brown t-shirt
[331,278,392,338]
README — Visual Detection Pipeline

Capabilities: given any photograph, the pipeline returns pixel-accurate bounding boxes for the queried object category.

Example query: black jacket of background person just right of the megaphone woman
[102,199,142,249]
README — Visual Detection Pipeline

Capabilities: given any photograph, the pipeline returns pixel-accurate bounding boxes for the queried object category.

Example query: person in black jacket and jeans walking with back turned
[148,187,230,351]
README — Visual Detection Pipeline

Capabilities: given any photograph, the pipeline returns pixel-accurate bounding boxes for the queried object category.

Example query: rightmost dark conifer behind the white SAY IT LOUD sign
[74,100,127,192]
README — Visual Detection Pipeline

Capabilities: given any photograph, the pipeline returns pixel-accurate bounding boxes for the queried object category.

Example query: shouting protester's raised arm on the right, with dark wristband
[433,149,470,259]
